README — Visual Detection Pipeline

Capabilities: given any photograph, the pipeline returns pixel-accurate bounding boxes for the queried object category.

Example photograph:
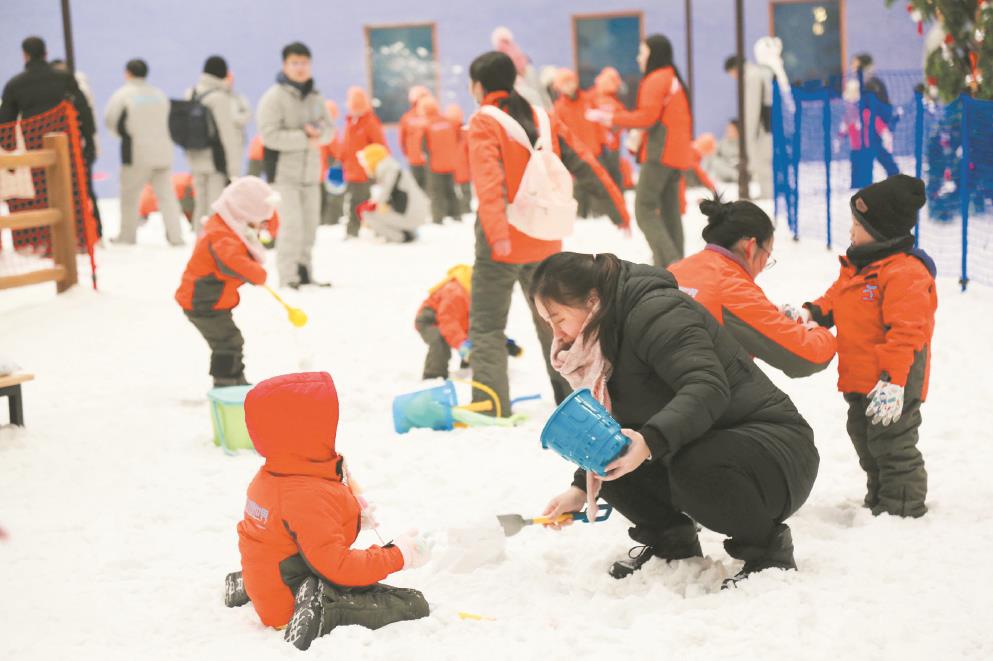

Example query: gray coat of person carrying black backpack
[186,73,246,179]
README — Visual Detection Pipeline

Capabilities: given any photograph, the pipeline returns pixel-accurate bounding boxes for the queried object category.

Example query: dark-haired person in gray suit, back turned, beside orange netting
[104,59,183,246]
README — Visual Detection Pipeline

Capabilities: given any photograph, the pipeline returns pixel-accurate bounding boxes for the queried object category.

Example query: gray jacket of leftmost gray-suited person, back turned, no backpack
[104,78,174,168]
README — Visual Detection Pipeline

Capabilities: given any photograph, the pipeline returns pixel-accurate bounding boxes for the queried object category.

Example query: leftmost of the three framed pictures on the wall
[365,23,438,124]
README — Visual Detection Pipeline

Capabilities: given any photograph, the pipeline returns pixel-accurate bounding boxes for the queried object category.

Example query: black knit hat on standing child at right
[851,174,927,241]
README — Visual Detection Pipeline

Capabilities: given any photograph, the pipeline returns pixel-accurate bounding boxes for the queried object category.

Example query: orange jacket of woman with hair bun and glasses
[668,244,837,378]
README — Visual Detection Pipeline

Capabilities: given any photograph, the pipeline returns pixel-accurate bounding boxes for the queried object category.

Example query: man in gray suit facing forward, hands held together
[258,42,331,288]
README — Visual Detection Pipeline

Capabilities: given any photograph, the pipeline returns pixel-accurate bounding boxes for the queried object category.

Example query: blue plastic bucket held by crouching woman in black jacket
[541,388,630,476]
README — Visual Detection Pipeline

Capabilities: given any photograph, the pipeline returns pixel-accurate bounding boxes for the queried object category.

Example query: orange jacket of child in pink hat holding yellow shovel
[176,213,266,313]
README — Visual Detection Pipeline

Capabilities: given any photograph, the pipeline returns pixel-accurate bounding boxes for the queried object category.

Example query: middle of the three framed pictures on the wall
[572,12,644,108]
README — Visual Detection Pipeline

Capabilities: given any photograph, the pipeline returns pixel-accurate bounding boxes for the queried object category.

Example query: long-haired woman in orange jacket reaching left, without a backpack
[595,34,693,266]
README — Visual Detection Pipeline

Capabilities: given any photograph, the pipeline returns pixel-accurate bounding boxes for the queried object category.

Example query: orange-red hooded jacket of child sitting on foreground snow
[238,372,403,627]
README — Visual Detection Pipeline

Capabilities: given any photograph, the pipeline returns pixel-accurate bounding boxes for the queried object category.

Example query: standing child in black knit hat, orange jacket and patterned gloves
[801,174,938,517]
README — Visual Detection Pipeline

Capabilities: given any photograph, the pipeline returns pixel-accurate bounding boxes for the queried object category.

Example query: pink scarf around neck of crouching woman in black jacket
[551,304,614,521]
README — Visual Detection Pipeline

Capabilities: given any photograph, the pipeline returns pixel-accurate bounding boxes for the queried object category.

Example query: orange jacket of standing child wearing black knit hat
[804,250,938,392]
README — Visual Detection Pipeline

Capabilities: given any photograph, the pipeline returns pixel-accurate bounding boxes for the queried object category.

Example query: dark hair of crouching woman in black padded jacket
[528,252,622,360]
